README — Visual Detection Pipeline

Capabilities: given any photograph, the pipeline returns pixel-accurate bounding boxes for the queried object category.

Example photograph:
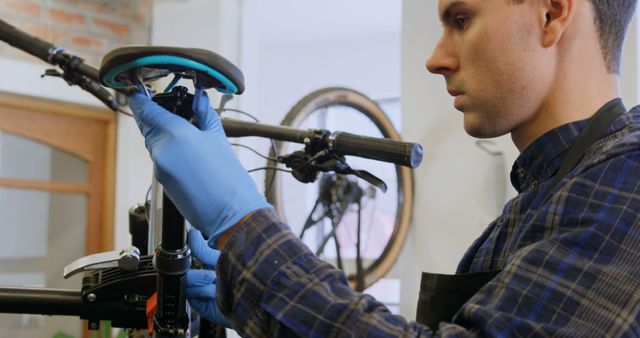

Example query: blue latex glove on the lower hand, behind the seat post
[187,228,231,327]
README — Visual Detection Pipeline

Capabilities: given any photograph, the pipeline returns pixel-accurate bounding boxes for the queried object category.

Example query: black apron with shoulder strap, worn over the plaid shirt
[416,99,626,330]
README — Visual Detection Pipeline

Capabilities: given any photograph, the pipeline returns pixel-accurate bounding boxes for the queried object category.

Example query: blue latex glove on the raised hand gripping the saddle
[129,90,271,243]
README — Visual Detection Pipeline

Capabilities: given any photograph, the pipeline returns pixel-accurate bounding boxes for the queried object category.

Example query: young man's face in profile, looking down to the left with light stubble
[426,0,553,137]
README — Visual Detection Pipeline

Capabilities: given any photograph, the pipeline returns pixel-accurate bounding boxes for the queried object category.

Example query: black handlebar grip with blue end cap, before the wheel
[331,132,423,168]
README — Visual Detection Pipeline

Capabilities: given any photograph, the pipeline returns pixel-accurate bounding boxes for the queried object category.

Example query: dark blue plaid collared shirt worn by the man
[217,104,640,337]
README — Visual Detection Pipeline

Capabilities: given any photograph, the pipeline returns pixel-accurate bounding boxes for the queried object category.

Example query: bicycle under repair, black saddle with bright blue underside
[0,20,422,337]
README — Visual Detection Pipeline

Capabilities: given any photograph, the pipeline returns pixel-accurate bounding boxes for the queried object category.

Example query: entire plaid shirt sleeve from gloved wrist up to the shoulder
[217,144,640,337]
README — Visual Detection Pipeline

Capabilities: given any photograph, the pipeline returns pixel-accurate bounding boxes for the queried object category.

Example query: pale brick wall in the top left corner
[0,0,152,67]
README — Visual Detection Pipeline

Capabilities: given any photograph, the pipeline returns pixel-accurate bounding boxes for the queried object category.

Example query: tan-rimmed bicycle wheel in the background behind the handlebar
[265,87,413,291]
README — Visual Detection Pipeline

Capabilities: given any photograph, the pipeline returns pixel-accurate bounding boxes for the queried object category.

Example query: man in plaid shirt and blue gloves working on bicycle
[131,0,640,337]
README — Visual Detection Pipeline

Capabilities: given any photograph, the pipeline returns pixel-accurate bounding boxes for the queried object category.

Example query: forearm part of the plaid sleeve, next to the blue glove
[217,209,432,337]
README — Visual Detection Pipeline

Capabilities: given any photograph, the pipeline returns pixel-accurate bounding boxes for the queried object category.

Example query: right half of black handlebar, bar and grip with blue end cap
[222,118,423,168]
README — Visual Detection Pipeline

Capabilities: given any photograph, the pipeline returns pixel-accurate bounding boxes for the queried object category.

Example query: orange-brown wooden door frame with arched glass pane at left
[0,92,117,254]
